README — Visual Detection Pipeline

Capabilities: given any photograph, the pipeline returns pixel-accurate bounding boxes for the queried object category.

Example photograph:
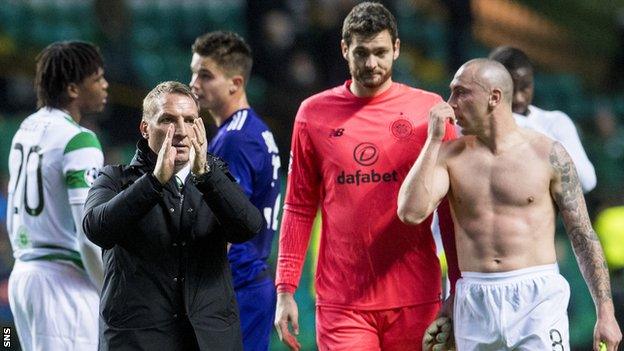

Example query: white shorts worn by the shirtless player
[453,264,570,351]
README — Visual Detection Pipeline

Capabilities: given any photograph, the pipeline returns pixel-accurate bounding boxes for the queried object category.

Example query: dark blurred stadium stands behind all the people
[0,0,624,350]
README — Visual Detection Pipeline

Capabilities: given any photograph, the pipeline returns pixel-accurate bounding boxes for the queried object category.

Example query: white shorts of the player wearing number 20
[9,260,99,351]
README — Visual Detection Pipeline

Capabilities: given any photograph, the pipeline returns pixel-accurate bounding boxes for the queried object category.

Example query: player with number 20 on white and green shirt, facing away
[7,41,108,351]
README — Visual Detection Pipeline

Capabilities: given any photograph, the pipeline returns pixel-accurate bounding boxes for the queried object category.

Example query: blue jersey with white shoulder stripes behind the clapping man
[208,108,281,289]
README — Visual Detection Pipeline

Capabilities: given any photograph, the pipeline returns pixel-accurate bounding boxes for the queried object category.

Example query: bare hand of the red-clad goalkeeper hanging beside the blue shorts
[275,292,301,351]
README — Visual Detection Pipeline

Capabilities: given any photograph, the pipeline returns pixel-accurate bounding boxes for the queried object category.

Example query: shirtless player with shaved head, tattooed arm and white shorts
[398,59,622,351]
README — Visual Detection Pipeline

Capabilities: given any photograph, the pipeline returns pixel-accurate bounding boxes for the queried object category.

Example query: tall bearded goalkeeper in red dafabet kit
[275,2,458,350]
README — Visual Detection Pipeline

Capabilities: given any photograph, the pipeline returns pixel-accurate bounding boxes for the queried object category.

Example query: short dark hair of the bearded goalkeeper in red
[342,1,399,46]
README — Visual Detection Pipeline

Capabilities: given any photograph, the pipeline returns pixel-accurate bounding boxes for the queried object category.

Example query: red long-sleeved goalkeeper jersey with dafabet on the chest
[276,81,456,310]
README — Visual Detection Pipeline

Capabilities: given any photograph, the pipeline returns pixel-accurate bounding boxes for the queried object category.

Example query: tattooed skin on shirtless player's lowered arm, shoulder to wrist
[549,142,611,304]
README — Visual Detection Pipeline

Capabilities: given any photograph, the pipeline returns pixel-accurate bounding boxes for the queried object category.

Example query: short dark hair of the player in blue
[192,31,253,83]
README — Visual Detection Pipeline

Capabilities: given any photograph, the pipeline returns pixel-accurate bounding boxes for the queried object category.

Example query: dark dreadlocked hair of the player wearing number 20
[35,41,104,108]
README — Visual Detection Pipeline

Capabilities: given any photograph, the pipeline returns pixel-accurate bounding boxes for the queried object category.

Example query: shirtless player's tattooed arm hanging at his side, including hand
[549,142,622,350]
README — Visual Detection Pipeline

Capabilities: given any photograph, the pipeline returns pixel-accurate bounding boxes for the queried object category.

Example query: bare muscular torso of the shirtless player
[445,130,556,272]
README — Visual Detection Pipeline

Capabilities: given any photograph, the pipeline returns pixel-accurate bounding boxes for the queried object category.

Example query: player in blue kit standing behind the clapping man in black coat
[190,31,280,351]
